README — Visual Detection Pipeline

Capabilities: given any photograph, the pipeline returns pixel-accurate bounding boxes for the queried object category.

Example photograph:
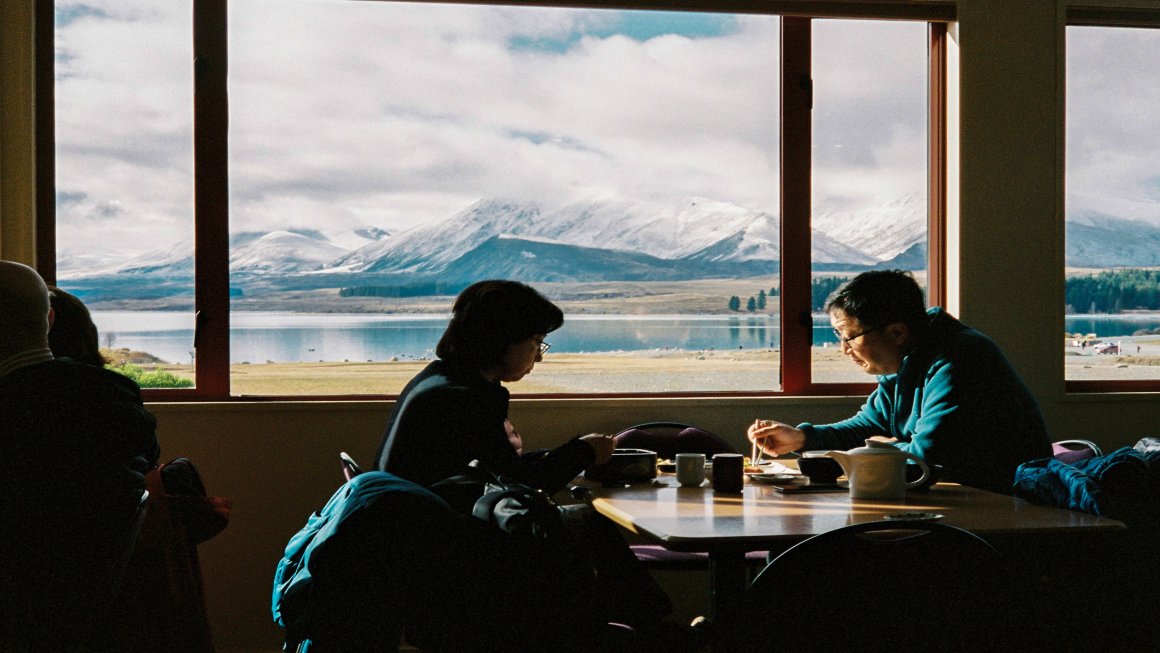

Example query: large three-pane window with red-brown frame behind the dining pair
[47,0,943,398]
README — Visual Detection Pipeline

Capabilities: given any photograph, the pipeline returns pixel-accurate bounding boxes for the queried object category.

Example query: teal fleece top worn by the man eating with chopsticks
[798,307,1051,494]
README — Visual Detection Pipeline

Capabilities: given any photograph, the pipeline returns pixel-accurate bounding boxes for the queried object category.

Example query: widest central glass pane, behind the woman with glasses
[230,0,778,394]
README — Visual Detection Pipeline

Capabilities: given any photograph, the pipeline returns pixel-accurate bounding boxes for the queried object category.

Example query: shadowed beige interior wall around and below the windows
[0,0,1160,652]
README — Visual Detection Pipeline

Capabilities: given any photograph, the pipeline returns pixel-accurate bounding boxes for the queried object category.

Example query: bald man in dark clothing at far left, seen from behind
[0,261,160,651]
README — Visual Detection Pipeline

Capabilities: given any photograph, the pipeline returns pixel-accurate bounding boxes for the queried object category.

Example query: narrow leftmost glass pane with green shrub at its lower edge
[55,0,195,387]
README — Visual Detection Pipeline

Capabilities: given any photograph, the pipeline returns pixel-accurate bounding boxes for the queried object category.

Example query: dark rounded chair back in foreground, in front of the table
[711,521,1030,652]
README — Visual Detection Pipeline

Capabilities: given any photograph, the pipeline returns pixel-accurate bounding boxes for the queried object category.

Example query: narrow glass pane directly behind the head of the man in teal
[811,20,929,383]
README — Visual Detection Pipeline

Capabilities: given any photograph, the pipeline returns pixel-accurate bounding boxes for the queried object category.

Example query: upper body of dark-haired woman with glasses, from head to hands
[376,281,615,493]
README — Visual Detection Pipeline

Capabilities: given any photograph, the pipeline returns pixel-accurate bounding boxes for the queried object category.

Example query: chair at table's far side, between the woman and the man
[612,422,769,571]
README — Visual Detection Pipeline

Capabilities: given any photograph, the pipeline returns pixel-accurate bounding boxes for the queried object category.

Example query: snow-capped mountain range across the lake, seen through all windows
[58,196,1160,296]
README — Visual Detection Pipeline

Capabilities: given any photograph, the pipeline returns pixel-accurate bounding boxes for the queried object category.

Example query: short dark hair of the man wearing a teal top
[826,270,927,327]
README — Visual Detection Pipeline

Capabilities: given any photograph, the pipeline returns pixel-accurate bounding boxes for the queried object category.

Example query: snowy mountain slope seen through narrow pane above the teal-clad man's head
[813,195,927,261]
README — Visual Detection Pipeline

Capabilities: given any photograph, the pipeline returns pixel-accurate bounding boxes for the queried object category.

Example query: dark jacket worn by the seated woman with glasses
[375,361,595,493]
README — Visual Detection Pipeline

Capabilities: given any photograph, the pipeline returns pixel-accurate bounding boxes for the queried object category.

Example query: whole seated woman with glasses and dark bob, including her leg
[376,281,673,638]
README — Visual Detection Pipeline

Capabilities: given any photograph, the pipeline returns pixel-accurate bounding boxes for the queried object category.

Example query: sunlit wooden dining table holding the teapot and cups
[587,474,1125,616]
